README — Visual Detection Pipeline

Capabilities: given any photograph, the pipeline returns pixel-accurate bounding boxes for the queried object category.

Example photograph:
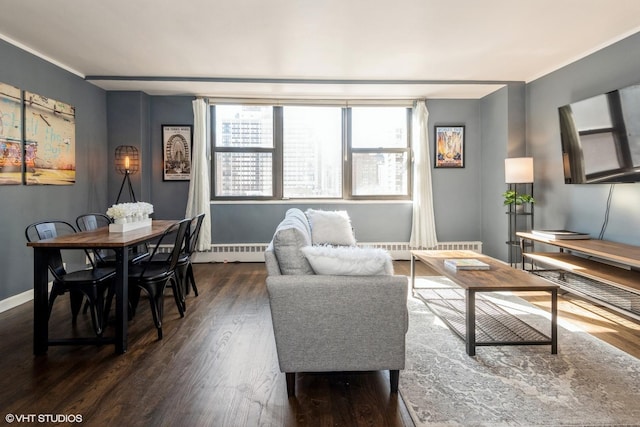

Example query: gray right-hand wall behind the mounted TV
[527,34,640,245]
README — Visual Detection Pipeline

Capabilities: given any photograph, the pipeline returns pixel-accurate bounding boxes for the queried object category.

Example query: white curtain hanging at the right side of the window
[409,100,438,249]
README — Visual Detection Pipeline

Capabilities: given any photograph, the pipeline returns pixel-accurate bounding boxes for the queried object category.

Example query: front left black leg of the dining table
[33,248,49,356]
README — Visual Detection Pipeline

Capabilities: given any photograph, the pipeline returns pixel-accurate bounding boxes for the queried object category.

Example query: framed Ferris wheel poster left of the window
[162,125,193,181]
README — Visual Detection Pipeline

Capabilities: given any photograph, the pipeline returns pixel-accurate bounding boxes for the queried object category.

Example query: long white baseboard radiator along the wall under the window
[162,241,482,262]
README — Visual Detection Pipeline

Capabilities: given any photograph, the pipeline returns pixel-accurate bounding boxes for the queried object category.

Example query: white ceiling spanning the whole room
[0,0,640,99]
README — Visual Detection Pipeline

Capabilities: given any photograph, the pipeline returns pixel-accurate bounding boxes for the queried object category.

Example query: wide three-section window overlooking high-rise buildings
[212,104,411,199]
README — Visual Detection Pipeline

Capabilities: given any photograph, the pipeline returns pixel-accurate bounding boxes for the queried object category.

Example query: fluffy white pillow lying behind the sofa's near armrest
[300,246,393,276]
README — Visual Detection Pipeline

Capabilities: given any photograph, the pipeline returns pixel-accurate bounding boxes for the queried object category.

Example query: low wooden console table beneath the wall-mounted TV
[517,232,640,320]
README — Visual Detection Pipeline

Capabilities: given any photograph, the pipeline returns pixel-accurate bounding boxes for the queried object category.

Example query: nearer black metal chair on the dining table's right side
[129,219,191,340]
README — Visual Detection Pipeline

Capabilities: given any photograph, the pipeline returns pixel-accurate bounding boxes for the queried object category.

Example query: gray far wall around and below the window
[108,92,482,244]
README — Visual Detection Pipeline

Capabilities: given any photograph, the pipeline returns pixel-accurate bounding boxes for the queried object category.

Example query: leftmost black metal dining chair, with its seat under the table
[25,220,115,337]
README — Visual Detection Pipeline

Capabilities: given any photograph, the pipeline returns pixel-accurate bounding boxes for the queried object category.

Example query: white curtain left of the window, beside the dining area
[185,99,211,251]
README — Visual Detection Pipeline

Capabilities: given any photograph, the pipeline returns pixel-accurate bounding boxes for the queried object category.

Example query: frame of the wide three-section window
[209,100,413,202]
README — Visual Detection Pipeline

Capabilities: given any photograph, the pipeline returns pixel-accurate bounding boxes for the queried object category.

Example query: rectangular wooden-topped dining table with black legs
[27,220,176,356]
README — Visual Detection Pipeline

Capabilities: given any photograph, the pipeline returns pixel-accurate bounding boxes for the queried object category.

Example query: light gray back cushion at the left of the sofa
[272,208,314,275]
